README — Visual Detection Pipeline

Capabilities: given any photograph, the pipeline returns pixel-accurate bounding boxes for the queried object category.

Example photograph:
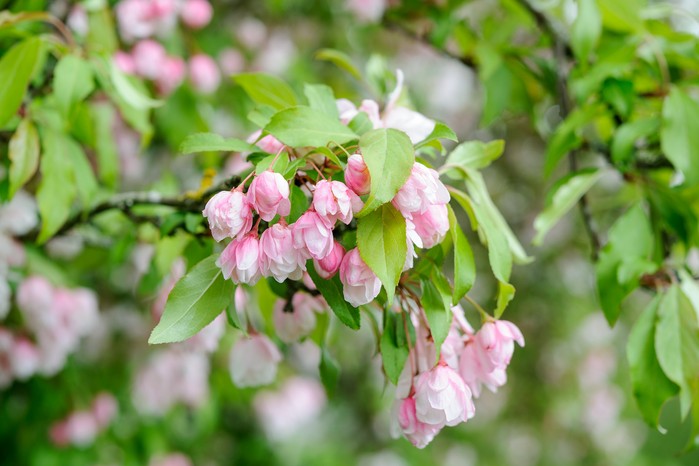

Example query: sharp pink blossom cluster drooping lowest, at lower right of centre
[395,305,524,448]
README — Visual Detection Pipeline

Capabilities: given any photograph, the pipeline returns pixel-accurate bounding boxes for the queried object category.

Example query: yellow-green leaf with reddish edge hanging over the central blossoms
[357,204,407,303]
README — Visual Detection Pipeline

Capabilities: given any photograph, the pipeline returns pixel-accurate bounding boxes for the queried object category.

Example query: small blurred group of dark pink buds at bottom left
[49,392,118,447]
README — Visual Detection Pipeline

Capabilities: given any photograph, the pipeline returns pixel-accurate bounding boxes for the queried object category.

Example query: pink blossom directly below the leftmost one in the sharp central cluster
[216,235,262,285]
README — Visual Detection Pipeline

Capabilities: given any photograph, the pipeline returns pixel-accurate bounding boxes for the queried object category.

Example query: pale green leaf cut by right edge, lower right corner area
[655,284,699,417]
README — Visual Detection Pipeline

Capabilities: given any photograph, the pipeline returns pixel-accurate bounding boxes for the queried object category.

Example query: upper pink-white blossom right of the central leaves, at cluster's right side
[393,162,450,215]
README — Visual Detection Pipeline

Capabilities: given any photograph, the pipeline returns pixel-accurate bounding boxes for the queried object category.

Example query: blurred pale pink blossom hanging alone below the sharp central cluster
[229,334,282,387]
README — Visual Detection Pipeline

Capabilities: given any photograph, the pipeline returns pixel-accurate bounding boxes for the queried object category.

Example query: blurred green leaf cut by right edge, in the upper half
[660,87,699,185]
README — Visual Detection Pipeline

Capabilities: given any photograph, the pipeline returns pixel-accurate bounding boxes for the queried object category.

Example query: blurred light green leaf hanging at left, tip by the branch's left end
[36,128,77,243]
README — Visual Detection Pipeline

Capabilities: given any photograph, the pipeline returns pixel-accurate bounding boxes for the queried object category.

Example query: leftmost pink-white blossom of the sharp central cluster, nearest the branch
[202,190,252,241]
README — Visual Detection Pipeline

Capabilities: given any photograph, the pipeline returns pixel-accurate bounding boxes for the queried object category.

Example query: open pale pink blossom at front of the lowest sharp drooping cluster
[415,363,476,427]
